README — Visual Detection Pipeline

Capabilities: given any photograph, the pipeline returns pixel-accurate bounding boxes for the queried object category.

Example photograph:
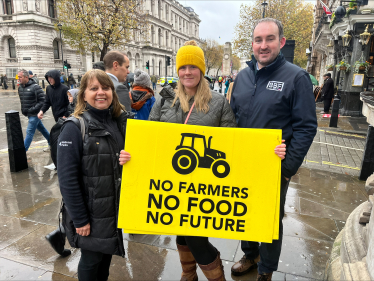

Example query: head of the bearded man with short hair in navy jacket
[252,22,286,69]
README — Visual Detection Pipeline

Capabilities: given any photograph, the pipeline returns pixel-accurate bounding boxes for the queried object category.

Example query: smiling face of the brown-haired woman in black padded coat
[84,78,113,110]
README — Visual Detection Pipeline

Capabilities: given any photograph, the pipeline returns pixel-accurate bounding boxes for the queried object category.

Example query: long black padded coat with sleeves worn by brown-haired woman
[57,106,129,256]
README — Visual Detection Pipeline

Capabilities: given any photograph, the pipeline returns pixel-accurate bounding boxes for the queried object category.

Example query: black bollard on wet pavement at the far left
[5,110,28,172]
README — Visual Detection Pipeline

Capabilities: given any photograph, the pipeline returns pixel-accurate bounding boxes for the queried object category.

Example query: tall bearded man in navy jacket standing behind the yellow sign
[230,18,317,280]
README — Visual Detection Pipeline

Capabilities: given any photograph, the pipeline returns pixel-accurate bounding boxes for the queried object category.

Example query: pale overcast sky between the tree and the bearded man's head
[183,0,316,44]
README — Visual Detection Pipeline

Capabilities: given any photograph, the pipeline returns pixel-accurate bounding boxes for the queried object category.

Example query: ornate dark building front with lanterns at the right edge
[307,0,374,116]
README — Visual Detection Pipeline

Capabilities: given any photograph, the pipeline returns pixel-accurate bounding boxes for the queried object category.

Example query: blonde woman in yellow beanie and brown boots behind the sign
[149,41,286,281]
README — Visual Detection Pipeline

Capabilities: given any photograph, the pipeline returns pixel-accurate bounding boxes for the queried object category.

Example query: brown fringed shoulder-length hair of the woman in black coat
[73,69,125,118]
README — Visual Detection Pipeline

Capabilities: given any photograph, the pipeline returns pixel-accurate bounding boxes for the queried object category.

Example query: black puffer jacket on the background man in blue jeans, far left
[18,79,45,116]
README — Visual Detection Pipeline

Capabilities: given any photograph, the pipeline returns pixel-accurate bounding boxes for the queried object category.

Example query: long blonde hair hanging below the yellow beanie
[171,71,212,113]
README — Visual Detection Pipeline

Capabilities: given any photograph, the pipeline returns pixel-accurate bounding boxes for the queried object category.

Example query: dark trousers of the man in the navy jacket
[241,176,290,274]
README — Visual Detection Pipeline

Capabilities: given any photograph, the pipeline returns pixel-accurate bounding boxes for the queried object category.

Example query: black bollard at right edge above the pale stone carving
[360,125,374,181]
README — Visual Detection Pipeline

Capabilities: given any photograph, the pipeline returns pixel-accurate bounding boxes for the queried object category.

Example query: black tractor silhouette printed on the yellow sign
[172,133,230,178]
